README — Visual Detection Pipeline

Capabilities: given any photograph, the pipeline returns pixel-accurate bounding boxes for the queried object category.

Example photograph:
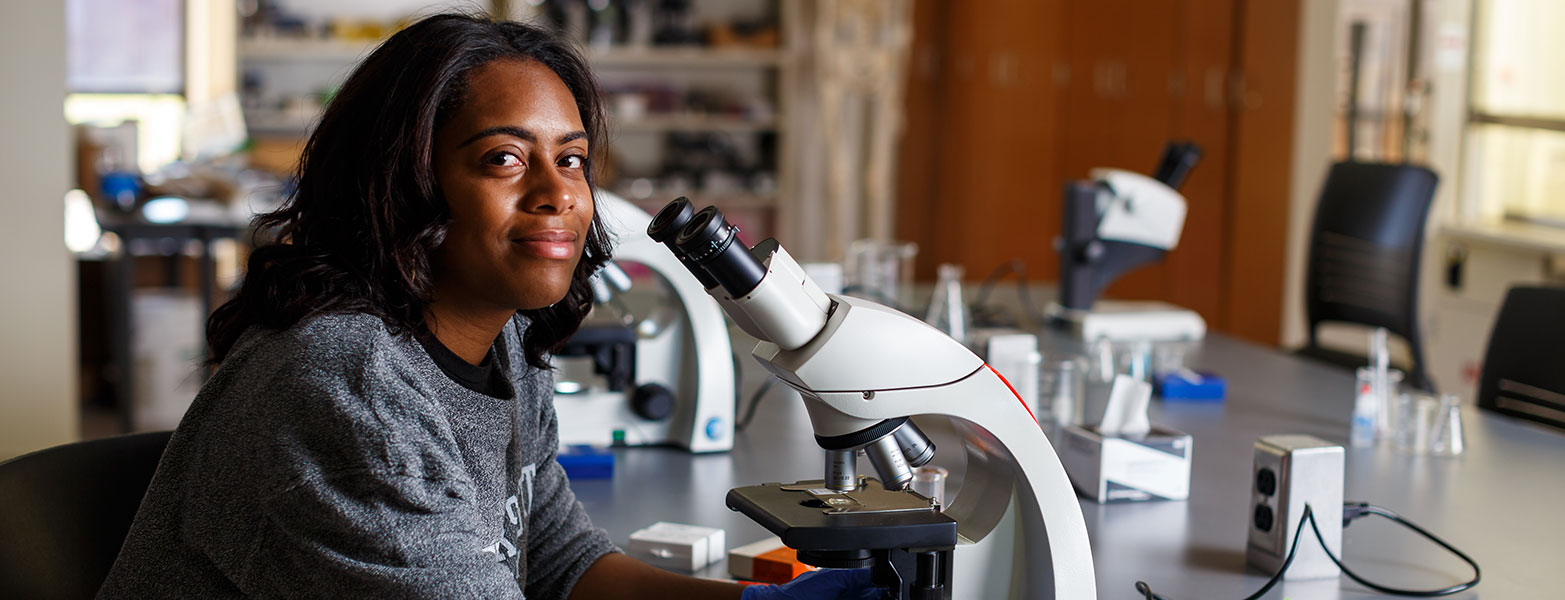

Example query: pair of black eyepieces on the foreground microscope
[646,197,767,298]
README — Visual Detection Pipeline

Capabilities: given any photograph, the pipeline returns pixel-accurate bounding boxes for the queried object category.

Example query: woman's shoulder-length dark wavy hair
[207,14,610,368]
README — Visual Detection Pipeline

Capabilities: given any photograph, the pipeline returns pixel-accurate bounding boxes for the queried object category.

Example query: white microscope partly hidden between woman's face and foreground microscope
[554,191,736,453]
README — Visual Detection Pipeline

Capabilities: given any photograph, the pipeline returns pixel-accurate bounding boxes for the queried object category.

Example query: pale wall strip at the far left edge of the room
[0,2,78,459]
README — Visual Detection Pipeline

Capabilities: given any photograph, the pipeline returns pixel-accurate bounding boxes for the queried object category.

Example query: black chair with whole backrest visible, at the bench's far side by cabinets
[1299,163,1440,392]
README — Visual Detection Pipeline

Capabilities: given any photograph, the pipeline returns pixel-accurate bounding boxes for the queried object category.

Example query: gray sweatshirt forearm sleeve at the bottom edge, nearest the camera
[236,470,523,598]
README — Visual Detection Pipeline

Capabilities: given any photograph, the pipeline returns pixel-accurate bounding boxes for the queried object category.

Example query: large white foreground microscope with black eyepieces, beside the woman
[648,197,1097,600]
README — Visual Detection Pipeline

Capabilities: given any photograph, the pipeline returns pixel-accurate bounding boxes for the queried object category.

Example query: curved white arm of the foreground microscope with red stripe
[753,296,1096,598]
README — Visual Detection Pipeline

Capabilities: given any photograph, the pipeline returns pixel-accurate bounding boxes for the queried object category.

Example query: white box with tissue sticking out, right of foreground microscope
[1058,425,1194,503]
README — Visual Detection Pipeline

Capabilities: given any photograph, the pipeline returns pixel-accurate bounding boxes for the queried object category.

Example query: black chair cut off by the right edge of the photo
[1477,287,1565,429]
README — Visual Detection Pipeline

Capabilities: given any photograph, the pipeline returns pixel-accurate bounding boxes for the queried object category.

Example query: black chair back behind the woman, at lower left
[0,431,172,598]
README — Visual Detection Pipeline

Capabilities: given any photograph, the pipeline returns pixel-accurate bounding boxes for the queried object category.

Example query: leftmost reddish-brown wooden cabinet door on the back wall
[898,0,1061,280]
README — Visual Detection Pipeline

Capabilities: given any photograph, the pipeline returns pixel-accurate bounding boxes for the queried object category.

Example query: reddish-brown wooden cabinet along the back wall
[897,0,1299,343]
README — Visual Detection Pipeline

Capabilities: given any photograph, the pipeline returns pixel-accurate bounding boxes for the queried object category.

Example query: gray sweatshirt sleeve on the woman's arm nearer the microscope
[526,380,620,600]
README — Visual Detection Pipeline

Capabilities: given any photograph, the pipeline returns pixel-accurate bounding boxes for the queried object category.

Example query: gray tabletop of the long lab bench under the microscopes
[573,335,1565,600]
